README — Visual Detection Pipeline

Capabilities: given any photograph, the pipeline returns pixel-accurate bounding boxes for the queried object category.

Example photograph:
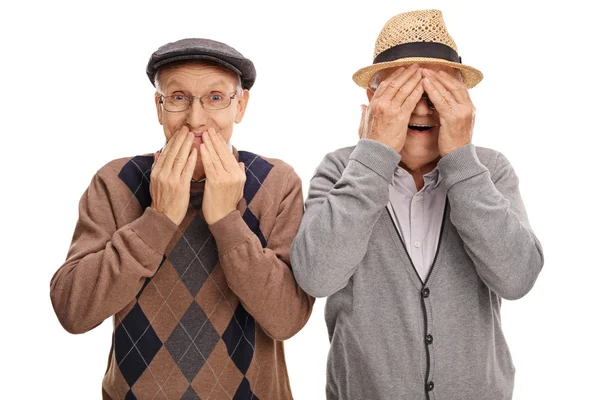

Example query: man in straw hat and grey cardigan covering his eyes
[291,10,543,400]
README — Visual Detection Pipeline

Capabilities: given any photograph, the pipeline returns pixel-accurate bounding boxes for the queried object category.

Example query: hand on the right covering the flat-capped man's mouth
[200,128,246,225]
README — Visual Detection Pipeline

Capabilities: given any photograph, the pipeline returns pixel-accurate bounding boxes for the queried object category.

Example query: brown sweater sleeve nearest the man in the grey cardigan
[209,169,314,340]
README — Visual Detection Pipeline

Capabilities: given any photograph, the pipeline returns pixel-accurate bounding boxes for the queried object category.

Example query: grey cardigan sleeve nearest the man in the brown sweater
[292,139,400,297]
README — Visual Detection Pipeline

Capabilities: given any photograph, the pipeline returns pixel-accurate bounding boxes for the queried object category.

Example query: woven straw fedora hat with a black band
[352,10,483,88]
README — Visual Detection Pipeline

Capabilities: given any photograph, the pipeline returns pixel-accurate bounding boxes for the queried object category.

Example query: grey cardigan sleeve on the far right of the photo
[438,144,544,300]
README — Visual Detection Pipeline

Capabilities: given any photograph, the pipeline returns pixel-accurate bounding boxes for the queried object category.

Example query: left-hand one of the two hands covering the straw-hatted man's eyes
[359,64,423,153]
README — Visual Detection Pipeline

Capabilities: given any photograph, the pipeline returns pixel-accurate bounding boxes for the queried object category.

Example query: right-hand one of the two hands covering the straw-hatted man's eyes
[423,70,475,157]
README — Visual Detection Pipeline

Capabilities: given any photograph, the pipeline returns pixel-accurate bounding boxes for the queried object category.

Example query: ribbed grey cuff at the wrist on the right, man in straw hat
[438,144,488,189]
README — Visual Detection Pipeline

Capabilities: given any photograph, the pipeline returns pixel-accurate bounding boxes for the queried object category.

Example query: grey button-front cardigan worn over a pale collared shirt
[291,139,543,400]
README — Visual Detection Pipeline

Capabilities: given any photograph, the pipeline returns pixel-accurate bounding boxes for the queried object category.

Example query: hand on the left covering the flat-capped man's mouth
[150,126,198,225]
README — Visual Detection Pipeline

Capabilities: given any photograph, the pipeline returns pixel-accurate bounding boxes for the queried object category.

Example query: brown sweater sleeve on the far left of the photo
[50,169,177,333]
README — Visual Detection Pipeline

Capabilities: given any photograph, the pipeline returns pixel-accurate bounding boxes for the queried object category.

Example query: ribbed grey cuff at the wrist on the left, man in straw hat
[350,139,400,182]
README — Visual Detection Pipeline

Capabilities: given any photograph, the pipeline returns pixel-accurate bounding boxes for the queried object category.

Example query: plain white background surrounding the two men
[0,0,600,400]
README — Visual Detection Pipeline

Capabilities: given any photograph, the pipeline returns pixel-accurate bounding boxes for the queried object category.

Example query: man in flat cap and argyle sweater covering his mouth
[51,39,314,400]
